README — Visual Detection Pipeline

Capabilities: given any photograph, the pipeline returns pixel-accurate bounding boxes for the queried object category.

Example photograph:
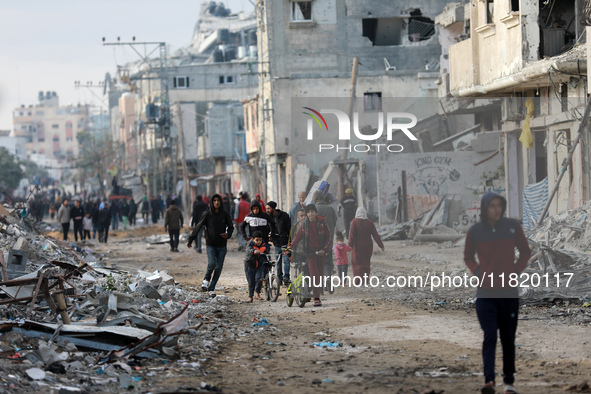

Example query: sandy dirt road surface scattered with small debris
[63,226,591,393]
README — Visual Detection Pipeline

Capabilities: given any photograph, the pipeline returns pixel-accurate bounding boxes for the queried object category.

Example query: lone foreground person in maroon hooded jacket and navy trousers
[464,192,531,394]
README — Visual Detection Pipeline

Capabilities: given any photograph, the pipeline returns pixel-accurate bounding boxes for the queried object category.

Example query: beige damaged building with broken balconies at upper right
[444,0,591,224]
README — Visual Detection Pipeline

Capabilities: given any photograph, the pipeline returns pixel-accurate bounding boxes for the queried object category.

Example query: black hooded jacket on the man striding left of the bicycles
[189,194,234,248]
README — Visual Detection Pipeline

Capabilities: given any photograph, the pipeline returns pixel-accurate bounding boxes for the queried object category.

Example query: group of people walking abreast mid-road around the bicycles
[185,189,384,306]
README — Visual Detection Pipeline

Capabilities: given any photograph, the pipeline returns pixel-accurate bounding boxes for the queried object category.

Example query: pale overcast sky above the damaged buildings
[0,0,254,130]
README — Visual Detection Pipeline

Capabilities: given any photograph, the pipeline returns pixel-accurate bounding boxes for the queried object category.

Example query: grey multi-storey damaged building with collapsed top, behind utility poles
[108,2,258,205]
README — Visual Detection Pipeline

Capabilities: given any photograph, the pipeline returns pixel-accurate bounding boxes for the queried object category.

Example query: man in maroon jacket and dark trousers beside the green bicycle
[290,204,332,306]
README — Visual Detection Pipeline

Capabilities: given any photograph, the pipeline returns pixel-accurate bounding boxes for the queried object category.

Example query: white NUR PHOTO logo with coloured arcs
[303,107,417,153]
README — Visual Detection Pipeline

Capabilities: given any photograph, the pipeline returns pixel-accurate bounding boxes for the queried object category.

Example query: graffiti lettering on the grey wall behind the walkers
[407,156,461,196]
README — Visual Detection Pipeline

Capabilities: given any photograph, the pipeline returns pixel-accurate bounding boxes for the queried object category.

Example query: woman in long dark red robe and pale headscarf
[349,207,384,277]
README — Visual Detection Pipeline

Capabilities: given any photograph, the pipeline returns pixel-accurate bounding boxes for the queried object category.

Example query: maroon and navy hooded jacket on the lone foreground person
[464,192,531,298]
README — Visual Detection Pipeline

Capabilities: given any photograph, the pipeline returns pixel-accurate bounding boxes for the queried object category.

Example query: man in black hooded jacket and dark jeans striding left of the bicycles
[187,194,234,297]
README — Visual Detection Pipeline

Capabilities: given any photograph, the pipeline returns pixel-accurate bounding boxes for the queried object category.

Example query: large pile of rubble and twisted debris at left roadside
[0,202,250,393]
